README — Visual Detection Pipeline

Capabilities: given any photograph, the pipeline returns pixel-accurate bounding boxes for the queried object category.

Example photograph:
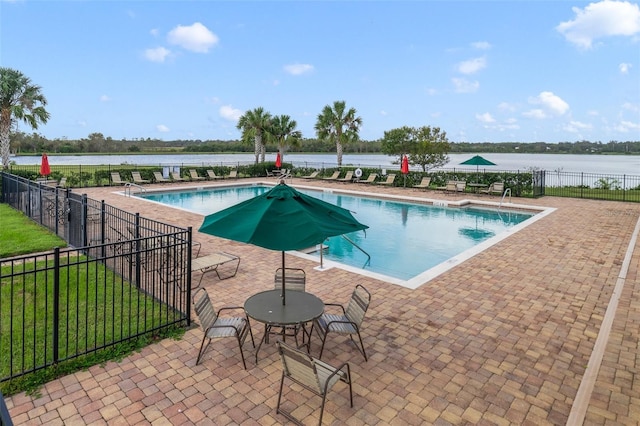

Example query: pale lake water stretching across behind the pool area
[11,153,640,175]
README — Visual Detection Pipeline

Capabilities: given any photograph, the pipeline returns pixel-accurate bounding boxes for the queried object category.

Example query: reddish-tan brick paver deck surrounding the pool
[5,179,640,425]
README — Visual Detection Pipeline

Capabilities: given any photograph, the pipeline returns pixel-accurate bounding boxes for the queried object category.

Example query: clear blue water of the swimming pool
[139,186,533,280]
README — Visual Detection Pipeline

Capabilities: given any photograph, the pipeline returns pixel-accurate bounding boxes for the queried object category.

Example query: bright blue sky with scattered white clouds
[0,0,640,143]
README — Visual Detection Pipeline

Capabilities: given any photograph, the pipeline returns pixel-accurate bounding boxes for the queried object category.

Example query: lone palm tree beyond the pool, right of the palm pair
[315,101,362,166]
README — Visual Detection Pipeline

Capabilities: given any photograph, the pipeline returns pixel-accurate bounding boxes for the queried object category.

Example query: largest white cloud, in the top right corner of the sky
[556,0,640,49]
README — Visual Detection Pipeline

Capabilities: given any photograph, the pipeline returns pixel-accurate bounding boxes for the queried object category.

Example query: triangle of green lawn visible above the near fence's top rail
[0,204,67,258]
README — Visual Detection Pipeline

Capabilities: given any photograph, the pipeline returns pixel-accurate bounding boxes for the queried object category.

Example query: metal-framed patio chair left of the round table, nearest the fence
[193,288,256,370]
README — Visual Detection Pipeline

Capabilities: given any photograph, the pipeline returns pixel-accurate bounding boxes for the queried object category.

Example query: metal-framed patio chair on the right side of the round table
[312,284,371,361]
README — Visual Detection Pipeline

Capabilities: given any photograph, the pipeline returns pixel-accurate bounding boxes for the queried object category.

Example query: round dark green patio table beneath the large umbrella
[244,290,324,364]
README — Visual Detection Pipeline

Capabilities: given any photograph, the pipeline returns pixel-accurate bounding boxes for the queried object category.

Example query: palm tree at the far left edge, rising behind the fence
[0,67,49,169]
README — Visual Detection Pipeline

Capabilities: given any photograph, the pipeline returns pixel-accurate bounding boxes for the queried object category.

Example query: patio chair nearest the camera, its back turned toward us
[276,342,353,425]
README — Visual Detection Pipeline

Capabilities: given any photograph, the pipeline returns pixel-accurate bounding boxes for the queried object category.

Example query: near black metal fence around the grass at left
[0,173,191,382]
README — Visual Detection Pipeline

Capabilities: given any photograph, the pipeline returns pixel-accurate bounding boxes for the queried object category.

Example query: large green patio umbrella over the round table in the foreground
[199,182,368,305]
